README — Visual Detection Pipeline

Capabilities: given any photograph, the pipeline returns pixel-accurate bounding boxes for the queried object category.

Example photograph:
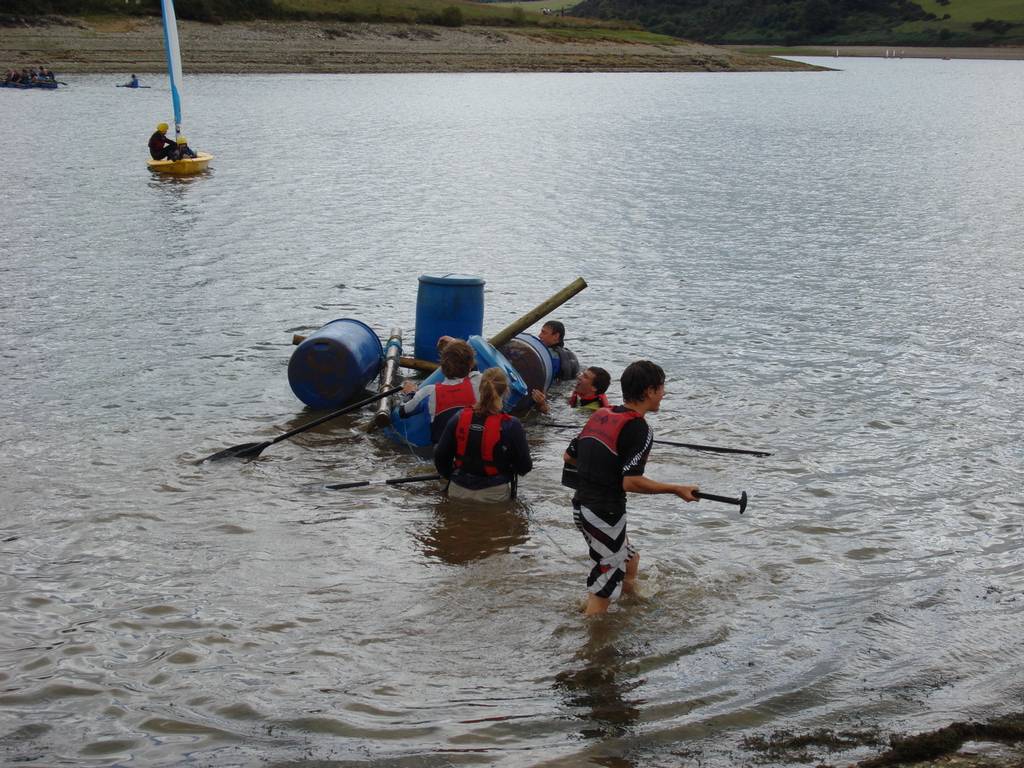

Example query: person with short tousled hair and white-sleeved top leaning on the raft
[398,336,480,444]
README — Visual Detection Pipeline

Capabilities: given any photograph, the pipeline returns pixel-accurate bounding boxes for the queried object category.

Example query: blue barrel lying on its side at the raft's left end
[288,317,384,411]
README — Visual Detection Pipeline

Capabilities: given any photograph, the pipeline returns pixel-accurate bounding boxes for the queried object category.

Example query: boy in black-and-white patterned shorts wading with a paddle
[563,360,697,615]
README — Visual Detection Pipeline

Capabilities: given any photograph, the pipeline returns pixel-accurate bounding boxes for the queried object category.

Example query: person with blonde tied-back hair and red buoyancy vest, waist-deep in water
[434,368,534,504]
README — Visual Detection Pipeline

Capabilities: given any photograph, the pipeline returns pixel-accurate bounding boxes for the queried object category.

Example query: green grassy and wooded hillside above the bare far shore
[8,0,1024,46]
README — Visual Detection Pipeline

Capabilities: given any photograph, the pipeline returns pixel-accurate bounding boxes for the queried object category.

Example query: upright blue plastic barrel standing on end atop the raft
[414,274,483,362]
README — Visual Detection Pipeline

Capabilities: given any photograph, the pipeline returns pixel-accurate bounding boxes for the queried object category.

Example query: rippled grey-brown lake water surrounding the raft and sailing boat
[0,59,1024,768]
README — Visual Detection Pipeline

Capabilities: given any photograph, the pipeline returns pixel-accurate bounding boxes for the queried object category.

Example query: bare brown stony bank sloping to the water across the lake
[0,17,817,76]
